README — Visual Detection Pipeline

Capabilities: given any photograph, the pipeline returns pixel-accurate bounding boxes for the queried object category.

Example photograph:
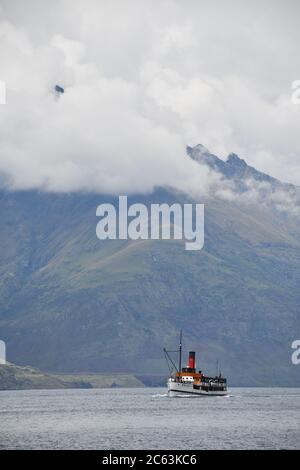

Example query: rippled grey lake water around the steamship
[0,388,300,450]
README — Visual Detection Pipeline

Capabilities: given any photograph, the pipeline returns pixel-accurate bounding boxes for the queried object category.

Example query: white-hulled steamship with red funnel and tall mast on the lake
[164,332,227,397]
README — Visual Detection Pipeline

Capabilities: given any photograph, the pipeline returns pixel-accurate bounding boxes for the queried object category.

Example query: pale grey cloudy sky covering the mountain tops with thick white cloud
[0,0,300,193]
